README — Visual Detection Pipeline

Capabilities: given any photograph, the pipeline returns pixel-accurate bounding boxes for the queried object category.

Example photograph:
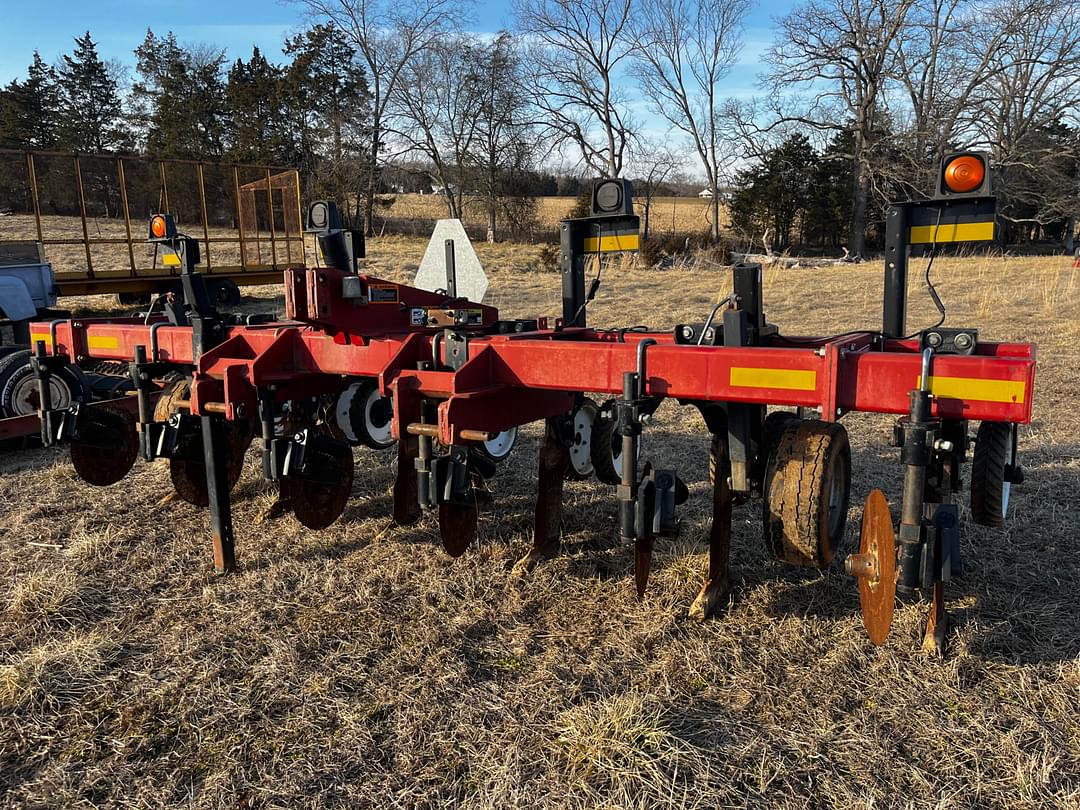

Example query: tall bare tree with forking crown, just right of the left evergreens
[295,0,468,233]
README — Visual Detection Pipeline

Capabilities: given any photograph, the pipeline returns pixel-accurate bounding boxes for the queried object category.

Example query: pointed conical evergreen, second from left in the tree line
[59,31,132,152]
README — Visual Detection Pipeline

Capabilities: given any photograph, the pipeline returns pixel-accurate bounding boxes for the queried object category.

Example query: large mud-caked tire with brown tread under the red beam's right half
[761,419,851,568]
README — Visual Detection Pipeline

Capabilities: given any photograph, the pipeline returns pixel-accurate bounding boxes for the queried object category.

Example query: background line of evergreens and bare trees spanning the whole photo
[0,0,1080,255]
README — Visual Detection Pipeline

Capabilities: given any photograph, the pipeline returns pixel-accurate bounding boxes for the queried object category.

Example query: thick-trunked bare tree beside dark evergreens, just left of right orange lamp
[766,0,917,256]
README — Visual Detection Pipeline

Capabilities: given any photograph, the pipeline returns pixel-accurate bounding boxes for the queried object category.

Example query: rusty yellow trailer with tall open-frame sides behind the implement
[0,149,305,305]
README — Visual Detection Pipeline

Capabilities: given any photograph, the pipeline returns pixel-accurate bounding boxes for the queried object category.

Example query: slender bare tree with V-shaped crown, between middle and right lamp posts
[633,0,750,239]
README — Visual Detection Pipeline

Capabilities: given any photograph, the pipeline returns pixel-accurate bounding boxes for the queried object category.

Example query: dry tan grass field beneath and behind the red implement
[0,239,1080,809]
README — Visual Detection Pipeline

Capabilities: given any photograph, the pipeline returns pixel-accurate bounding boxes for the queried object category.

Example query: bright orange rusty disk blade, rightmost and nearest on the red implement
[858,489,896,645]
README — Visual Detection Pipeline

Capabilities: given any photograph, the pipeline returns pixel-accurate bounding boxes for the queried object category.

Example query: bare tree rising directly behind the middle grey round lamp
[515,0,634,177]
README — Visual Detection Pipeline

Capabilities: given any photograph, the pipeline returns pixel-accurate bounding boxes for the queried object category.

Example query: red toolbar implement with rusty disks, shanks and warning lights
[27,153,1036,650]
